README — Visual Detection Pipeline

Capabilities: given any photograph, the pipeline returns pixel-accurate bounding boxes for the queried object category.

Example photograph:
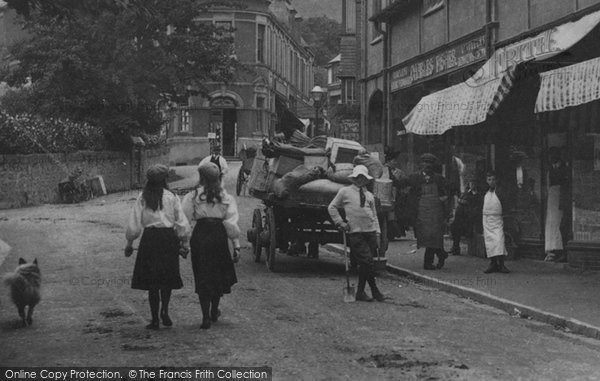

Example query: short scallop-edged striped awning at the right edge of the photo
[535,57,600,113]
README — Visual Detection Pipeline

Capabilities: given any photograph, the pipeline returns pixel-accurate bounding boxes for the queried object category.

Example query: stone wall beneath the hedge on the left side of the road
[0,148,169,209]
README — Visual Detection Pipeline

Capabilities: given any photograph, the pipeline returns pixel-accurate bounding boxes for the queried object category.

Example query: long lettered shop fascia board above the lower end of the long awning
[391,35,487,91]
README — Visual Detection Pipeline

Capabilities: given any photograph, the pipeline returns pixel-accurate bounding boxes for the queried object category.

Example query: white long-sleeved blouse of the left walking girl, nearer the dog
[125,189,192,241]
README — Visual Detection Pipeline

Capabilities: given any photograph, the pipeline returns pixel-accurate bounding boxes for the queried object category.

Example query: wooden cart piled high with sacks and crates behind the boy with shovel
[248,138,393,271]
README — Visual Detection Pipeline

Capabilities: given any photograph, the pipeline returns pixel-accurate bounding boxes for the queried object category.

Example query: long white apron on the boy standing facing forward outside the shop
[483,192,506,258]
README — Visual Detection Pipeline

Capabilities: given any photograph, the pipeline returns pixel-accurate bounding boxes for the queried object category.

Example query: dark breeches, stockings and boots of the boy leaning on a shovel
[348,232,380,295]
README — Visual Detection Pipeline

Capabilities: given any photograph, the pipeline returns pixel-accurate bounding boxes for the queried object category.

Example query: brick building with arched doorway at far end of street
[169,0,314,164]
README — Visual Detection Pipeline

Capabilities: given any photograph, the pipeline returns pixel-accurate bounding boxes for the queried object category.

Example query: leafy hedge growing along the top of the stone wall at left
[0,112,106,154]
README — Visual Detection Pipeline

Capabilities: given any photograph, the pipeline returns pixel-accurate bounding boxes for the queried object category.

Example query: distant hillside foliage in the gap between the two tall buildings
[299,16,341,66]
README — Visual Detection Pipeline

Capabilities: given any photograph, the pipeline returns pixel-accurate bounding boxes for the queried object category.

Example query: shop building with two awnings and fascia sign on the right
[368,0,600,267]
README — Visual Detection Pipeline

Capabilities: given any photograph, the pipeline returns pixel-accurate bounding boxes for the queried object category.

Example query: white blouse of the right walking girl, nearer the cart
[182,187,240,247]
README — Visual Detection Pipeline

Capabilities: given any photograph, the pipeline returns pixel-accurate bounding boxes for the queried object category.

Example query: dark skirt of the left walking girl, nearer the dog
[131,228,183,290]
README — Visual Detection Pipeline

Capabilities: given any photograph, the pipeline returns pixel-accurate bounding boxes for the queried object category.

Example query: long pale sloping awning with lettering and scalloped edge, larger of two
[402,11,600,135]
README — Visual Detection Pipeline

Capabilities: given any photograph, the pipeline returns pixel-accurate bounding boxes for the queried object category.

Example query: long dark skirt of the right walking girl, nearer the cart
[190,218,237,298]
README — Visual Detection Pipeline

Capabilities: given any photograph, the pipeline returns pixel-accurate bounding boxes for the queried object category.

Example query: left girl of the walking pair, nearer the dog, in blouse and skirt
[125,165,191,329]
